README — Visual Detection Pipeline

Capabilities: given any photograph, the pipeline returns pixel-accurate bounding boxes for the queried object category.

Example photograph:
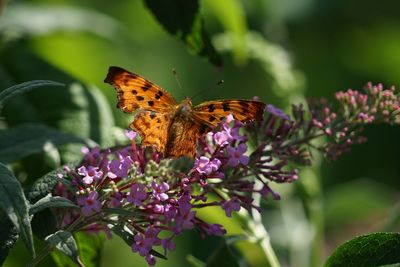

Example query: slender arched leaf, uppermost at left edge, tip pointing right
[0,80,65,107]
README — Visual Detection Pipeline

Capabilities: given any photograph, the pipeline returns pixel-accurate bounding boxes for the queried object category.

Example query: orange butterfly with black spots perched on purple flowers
[104,66,265,158]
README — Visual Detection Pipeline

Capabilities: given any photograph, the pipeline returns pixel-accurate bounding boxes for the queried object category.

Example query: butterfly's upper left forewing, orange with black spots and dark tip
[104,67,177,113]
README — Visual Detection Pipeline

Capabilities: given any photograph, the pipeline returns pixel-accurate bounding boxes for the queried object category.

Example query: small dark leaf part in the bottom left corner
[0,216,19,266]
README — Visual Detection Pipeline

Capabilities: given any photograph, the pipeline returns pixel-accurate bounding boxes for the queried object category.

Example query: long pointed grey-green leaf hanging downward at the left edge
[0,163,35,256]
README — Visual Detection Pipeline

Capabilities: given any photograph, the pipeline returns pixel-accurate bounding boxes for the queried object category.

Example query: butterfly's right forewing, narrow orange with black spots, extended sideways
[192,100,265,126]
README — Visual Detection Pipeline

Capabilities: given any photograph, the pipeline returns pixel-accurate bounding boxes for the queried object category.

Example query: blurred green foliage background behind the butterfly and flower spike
[0,0,400,266]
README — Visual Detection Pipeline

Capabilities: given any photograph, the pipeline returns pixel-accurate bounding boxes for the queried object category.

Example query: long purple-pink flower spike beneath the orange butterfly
[54,84,400,265]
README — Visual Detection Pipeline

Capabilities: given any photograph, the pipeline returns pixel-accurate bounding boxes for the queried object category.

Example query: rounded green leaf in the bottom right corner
[325,233,400,267]
